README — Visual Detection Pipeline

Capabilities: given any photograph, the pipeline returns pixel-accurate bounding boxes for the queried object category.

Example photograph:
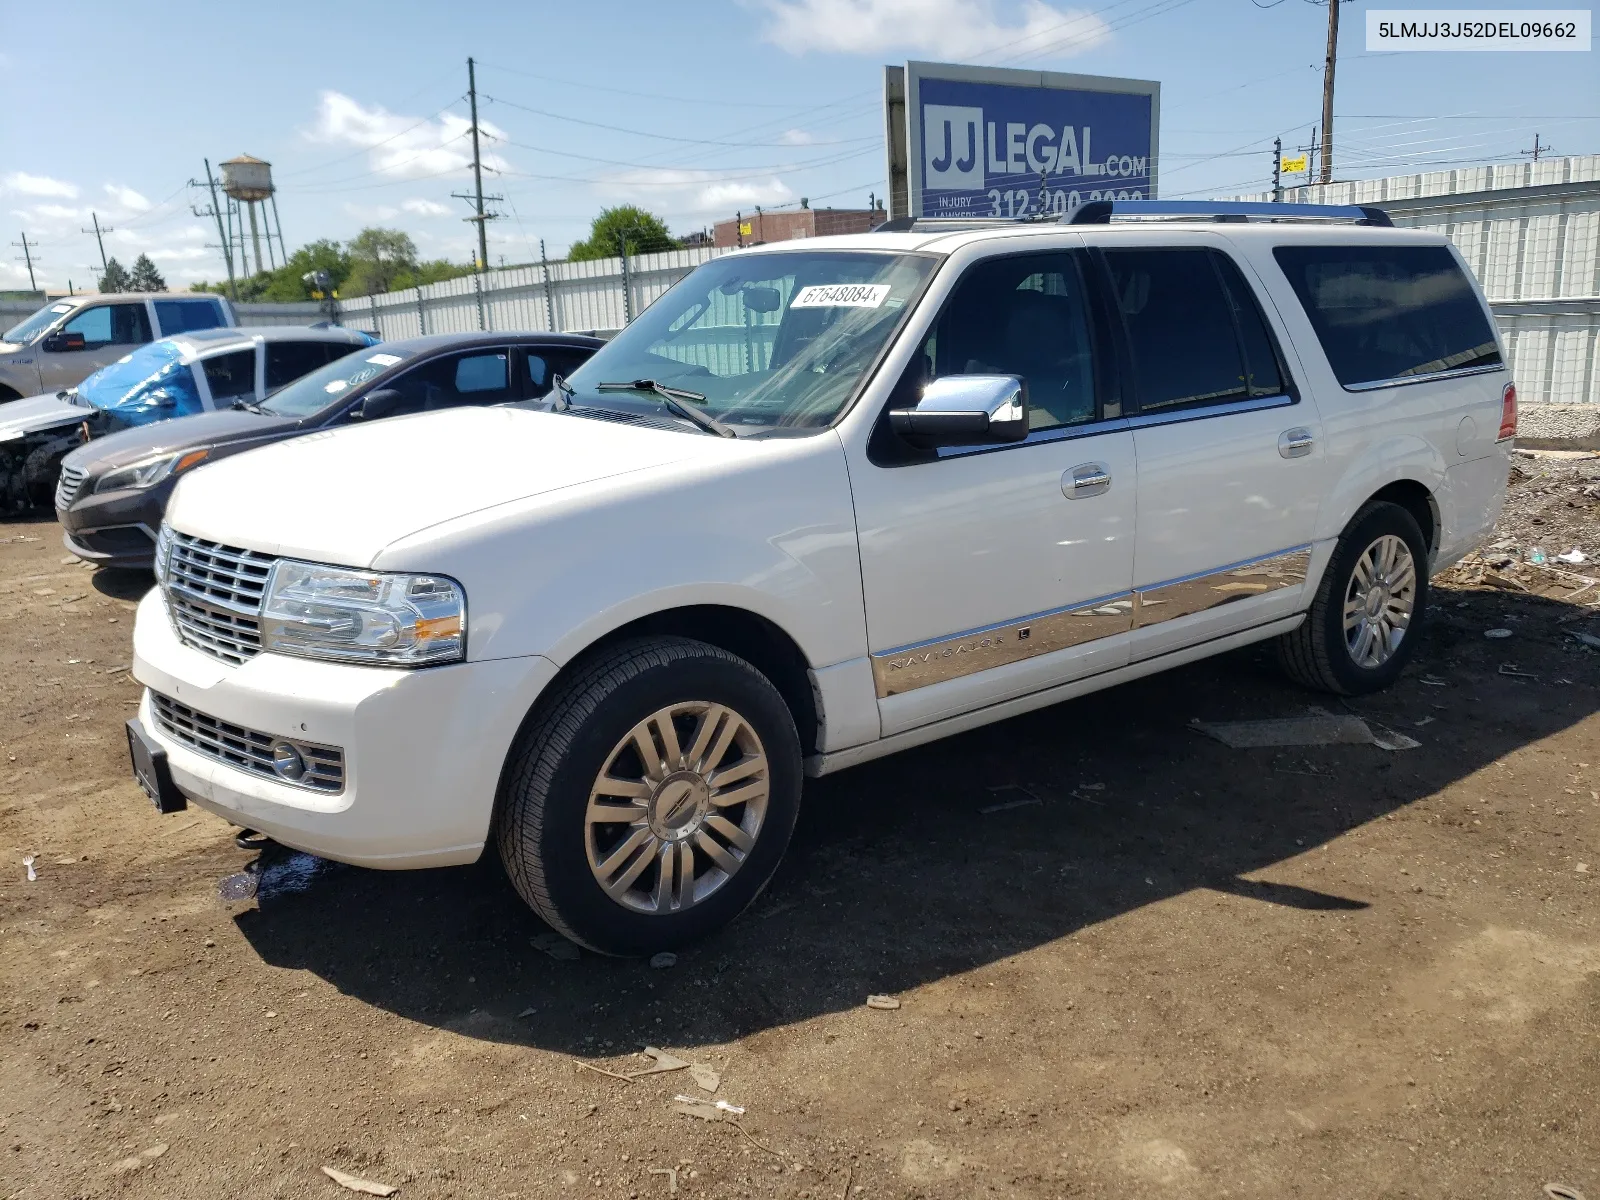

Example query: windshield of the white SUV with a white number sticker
[566,251,936,432]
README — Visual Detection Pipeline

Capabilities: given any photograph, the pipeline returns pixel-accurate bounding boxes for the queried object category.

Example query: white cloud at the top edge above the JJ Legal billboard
[760,0,1110,62]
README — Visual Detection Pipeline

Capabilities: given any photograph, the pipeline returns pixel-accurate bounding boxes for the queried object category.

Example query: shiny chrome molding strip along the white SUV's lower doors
[872,546,1310,699]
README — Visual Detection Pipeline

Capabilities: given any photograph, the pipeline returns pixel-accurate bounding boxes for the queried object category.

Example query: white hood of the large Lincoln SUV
[166,408,736,566]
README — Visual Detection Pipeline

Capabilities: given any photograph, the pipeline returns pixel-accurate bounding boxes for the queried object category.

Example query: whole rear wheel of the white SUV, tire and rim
[1278,501,1427,696]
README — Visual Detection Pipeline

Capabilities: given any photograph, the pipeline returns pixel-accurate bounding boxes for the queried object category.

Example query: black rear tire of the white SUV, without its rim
[1277,501,1429,696]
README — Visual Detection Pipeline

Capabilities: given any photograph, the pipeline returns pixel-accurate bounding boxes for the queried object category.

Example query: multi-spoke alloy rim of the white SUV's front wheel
[584,701,771,914]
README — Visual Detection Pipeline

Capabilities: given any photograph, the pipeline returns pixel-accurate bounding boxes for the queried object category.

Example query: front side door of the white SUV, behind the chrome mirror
[851,251,1134,734]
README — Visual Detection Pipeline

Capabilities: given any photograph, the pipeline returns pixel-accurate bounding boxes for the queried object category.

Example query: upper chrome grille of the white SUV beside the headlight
[157,528,277,664]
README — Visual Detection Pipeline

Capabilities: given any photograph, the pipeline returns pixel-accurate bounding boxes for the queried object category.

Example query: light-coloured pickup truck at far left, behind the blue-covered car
[0,291,237,403]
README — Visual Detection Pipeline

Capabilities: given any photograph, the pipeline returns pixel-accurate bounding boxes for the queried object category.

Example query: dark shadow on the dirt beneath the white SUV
[235,597,1600,1056]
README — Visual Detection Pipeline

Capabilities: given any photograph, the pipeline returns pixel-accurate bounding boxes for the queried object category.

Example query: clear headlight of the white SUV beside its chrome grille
[261,558,467,667]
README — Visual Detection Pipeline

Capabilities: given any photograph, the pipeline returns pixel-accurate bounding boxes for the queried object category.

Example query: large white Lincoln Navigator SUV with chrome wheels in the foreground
[128,202,1515,954]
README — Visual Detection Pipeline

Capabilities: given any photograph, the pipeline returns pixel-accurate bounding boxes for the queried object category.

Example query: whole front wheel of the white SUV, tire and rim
[498,637,802,955]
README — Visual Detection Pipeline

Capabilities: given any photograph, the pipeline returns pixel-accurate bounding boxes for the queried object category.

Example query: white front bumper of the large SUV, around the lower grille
[133,589,557,869]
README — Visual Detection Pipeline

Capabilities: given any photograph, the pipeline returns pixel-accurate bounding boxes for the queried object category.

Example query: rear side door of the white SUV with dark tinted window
[1104,243,1326,659]
